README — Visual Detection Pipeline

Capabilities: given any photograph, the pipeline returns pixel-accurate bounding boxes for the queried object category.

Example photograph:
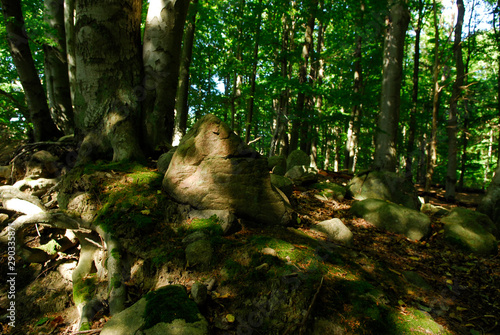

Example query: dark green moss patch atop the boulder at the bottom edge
[144,285,200,329]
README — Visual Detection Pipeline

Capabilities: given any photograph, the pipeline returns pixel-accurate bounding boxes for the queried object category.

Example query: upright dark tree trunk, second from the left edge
[44,0,74,135]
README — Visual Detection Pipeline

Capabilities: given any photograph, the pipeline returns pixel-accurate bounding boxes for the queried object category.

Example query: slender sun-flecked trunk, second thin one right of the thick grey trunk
[425,0,441,202]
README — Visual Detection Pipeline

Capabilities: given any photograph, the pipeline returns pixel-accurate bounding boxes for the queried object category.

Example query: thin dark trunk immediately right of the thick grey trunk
[405,0,424,180]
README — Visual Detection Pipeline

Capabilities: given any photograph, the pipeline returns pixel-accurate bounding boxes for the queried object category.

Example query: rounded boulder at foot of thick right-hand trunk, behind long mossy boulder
[347,171,421,210]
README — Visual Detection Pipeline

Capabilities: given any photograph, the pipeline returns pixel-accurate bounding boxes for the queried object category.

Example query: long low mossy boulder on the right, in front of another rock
[351,199,431,240]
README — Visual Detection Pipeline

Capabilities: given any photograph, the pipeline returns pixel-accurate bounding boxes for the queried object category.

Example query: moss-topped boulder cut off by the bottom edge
[101,285,209,335]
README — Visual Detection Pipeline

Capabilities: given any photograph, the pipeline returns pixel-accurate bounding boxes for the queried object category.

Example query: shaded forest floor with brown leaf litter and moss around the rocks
[0,166,500,335]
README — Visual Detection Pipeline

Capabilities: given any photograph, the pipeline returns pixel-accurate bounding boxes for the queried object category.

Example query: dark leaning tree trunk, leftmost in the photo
[2,0,61,142]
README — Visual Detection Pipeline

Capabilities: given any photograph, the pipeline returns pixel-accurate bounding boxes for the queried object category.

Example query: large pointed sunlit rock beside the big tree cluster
[163,114,293,225]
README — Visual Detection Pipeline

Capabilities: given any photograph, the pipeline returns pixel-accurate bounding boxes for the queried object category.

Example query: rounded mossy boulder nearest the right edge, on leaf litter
[441,208,498,255]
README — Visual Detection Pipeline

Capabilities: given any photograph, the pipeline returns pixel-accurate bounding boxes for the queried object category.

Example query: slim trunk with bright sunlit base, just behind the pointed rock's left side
[173,0,198,145]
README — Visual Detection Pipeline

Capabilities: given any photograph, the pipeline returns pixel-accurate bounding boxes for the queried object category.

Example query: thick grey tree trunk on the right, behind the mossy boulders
[374,0,410,171]
